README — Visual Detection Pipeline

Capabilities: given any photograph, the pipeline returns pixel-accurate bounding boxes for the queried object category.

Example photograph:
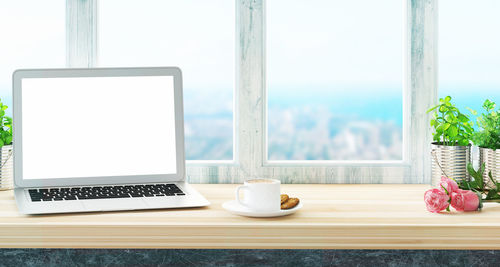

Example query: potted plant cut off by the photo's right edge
[471,99,500,187]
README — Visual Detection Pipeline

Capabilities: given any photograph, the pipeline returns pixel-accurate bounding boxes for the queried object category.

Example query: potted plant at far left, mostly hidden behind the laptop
[0,99,13,190]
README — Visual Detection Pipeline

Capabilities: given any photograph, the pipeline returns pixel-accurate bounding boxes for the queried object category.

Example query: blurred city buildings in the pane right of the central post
[268,106,402,160]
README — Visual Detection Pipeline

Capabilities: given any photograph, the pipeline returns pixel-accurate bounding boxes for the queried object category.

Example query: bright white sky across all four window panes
[0,0,500,100]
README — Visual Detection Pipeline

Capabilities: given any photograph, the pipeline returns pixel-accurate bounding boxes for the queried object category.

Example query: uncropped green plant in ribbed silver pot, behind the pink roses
[427,96,474,185]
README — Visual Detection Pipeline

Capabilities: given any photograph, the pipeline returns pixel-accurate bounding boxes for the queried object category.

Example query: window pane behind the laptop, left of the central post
[99,0,235,160]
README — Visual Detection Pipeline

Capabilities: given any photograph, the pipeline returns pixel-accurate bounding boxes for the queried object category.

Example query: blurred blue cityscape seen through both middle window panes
[184,91,402,160]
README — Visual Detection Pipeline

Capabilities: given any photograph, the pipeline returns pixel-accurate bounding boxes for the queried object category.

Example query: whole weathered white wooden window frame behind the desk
[66,0,437,183]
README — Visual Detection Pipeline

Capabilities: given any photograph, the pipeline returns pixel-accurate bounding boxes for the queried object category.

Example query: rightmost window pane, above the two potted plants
[439,0,500,115]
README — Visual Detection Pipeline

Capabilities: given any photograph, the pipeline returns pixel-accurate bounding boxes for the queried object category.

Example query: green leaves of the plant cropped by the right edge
[470,99,500,150]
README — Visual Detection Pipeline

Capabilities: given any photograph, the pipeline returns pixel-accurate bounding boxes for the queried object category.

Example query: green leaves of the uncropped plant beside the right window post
[427,96,474,146]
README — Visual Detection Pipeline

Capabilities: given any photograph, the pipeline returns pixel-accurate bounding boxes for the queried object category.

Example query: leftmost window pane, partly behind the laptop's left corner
[0,0,66,116]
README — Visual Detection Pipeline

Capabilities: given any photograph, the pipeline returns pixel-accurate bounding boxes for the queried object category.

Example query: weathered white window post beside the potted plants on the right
[410,0,438,183]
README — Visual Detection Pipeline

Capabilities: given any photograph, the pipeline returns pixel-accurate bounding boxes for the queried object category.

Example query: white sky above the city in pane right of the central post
[266,0,403,91]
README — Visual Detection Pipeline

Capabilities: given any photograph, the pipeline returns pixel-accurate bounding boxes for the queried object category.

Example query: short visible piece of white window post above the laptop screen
[66,0,97,68]
